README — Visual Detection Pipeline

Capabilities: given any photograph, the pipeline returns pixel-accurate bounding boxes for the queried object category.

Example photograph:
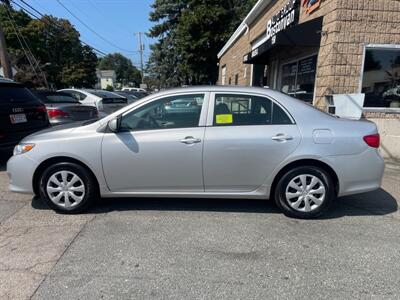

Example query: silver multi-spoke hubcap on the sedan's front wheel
[46,171,85,208]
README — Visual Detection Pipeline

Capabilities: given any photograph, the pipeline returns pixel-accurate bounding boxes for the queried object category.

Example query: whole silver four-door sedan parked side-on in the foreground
[7,86,384,218]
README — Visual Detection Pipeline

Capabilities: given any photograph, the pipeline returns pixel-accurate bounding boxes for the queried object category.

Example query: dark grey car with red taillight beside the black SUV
[34,91,99,125]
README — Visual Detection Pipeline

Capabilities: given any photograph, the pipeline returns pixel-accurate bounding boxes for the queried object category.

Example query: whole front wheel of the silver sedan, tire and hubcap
[39,162,98,214]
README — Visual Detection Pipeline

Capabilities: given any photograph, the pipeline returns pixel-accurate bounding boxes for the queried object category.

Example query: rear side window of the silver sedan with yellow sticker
[214,94,292,126]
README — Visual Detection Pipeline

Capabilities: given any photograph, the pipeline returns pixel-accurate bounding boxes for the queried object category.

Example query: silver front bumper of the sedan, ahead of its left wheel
[7,154,38,194]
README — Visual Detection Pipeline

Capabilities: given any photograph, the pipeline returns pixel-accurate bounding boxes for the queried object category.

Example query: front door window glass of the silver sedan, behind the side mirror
[120,94,204,131]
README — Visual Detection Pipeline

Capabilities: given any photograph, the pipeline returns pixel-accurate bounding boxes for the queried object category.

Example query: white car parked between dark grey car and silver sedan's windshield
[59,89,128,118]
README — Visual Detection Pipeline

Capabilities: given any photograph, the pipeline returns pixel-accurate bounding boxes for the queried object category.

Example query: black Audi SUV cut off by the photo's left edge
[0,79,50,152]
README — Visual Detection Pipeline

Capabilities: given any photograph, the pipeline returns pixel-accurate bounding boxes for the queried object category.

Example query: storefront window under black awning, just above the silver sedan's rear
[281,55,317,103]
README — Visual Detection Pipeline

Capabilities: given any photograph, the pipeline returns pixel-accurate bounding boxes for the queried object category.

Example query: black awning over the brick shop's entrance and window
[243,17,323,64]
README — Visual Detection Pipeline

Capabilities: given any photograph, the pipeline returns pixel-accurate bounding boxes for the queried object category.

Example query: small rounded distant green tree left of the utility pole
[98,53,142,86]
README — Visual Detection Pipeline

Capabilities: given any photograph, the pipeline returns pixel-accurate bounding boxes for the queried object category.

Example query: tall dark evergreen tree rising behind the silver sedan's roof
[148,0,256,87]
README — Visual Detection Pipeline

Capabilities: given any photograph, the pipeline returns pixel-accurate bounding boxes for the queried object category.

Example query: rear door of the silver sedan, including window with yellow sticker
[203,93,301,193]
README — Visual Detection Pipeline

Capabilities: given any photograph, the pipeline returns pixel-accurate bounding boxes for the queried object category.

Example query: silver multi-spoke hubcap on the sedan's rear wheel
[286,174,326,212]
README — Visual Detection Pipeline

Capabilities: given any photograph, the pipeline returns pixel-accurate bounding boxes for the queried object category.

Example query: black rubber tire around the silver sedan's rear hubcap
[274,166,336,219]
